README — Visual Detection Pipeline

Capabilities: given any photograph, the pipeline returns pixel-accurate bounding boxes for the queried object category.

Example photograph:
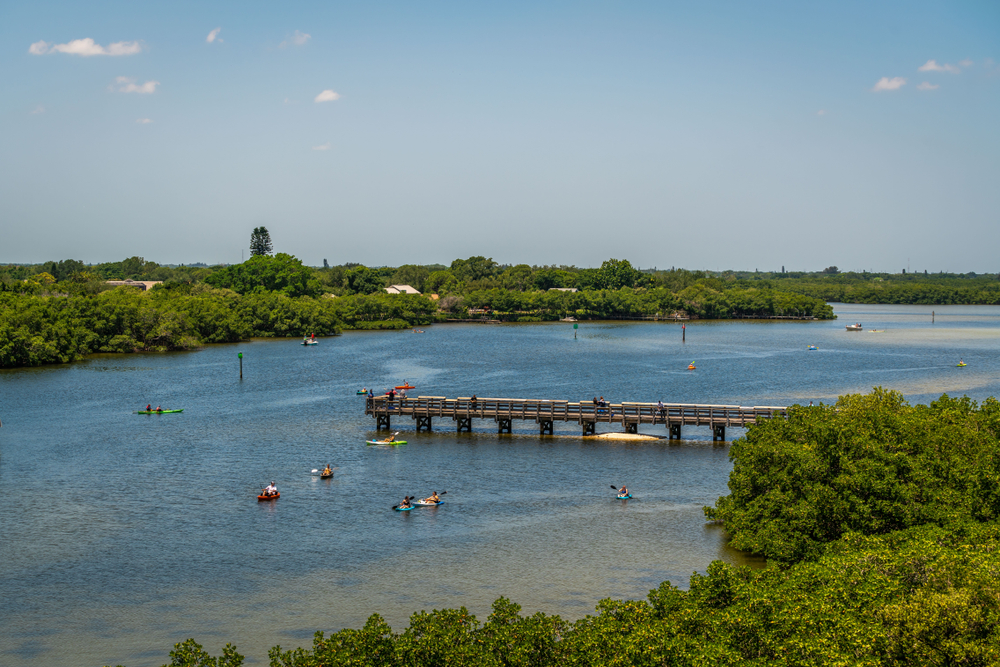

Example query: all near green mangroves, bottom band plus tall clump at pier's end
[141,390,1000,667]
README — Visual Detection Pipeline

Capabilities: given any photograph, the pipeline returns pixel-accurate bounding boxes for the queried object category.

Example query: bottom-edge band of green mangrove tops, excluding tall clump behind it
[148,524,1000,667]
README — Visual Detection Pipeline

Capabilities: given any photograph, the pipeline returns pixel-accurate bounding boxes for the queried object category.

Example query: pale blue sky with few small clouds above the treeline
[0,0,1000,273]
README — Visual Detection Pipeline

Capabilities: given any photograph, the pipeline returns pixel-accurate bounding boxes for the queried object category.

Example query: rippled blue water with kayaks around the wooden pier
[0,306,1000,667]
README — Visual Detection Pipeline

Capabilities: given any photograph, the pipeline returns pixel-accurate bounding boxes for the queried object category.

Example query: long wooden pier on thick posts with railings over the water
[365,396,787,440]
